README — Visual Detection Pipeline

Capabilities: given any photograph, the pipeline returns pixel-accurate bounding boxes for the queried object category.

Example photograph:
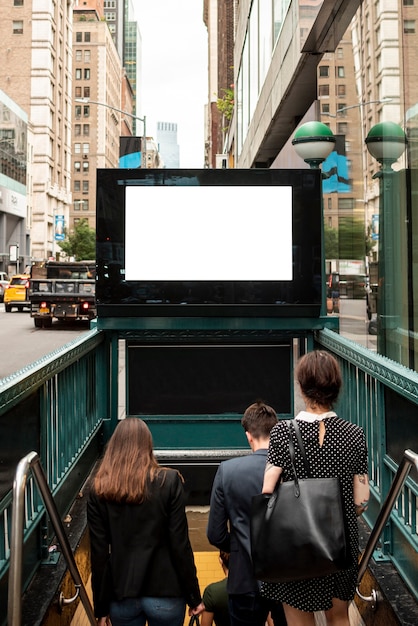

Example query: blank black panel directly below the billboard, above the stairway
[127,342,292,417]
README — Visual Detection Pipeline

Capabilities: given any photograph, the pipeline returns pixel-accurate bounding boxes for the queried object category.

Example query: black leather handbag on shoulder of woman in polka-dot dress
[251,420,352,582]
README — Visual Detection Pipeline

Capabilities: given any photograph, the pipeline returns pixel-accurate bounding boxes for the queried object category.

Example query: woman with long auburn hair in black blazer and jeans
[87,417,204,626]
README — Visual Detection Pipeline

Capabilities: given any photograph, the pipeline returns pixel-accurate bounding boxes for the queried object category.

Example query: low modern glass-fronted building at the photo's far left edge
[0,91,31,276]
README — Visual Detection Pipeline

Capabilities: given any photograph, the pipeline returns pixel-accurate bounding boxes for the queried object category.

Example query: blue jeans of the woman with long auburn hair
[110,598,186,626]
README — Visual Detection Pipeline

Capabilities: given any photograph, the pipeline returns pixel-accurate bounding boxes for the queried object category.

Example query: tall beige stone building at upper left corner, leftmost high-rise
[0,0,72,260]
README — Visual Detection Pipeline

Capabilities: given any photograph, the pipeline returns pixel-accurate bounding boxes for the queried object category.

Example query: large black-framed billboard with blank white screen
[96,169,323,317]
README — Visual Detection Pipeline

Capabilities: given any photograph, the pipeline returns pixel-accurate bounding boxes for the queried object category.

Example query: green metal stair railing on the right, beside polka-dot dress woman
[315,330,418,599]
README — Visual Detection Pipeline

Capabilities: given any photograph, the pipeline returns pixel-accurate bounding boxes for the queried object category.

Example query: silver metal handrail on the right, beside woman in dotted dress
[356,449,418,604]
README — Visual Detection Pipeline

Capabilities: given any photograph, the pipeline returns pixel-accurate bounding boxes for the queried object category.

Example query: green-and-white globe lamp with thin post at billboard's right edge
[292,122,335,316]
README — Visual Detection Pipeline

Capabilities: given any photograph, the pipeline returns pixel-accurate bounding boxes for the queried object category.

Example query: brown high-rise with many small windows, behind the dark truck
[69,3,124,229]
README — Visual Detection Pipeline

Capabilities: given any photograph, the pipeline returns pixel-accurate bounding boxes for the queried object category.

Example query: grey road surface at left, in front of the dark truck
[0,303,89,379]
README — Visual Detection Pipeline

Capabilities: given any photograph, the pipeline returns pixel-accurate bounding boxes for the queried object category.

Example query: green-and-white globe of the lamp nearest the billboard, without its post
[292,122,335,169]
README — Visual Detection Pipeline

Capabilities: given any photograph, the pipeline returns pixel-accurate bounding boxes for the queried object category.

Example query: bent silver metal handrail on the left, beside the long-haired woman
[7,452,97,626]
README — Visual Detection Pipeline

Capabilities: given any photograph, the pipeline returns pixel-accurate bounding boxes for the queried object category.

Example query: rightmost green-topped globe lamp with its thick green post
[365,122,408,356]
